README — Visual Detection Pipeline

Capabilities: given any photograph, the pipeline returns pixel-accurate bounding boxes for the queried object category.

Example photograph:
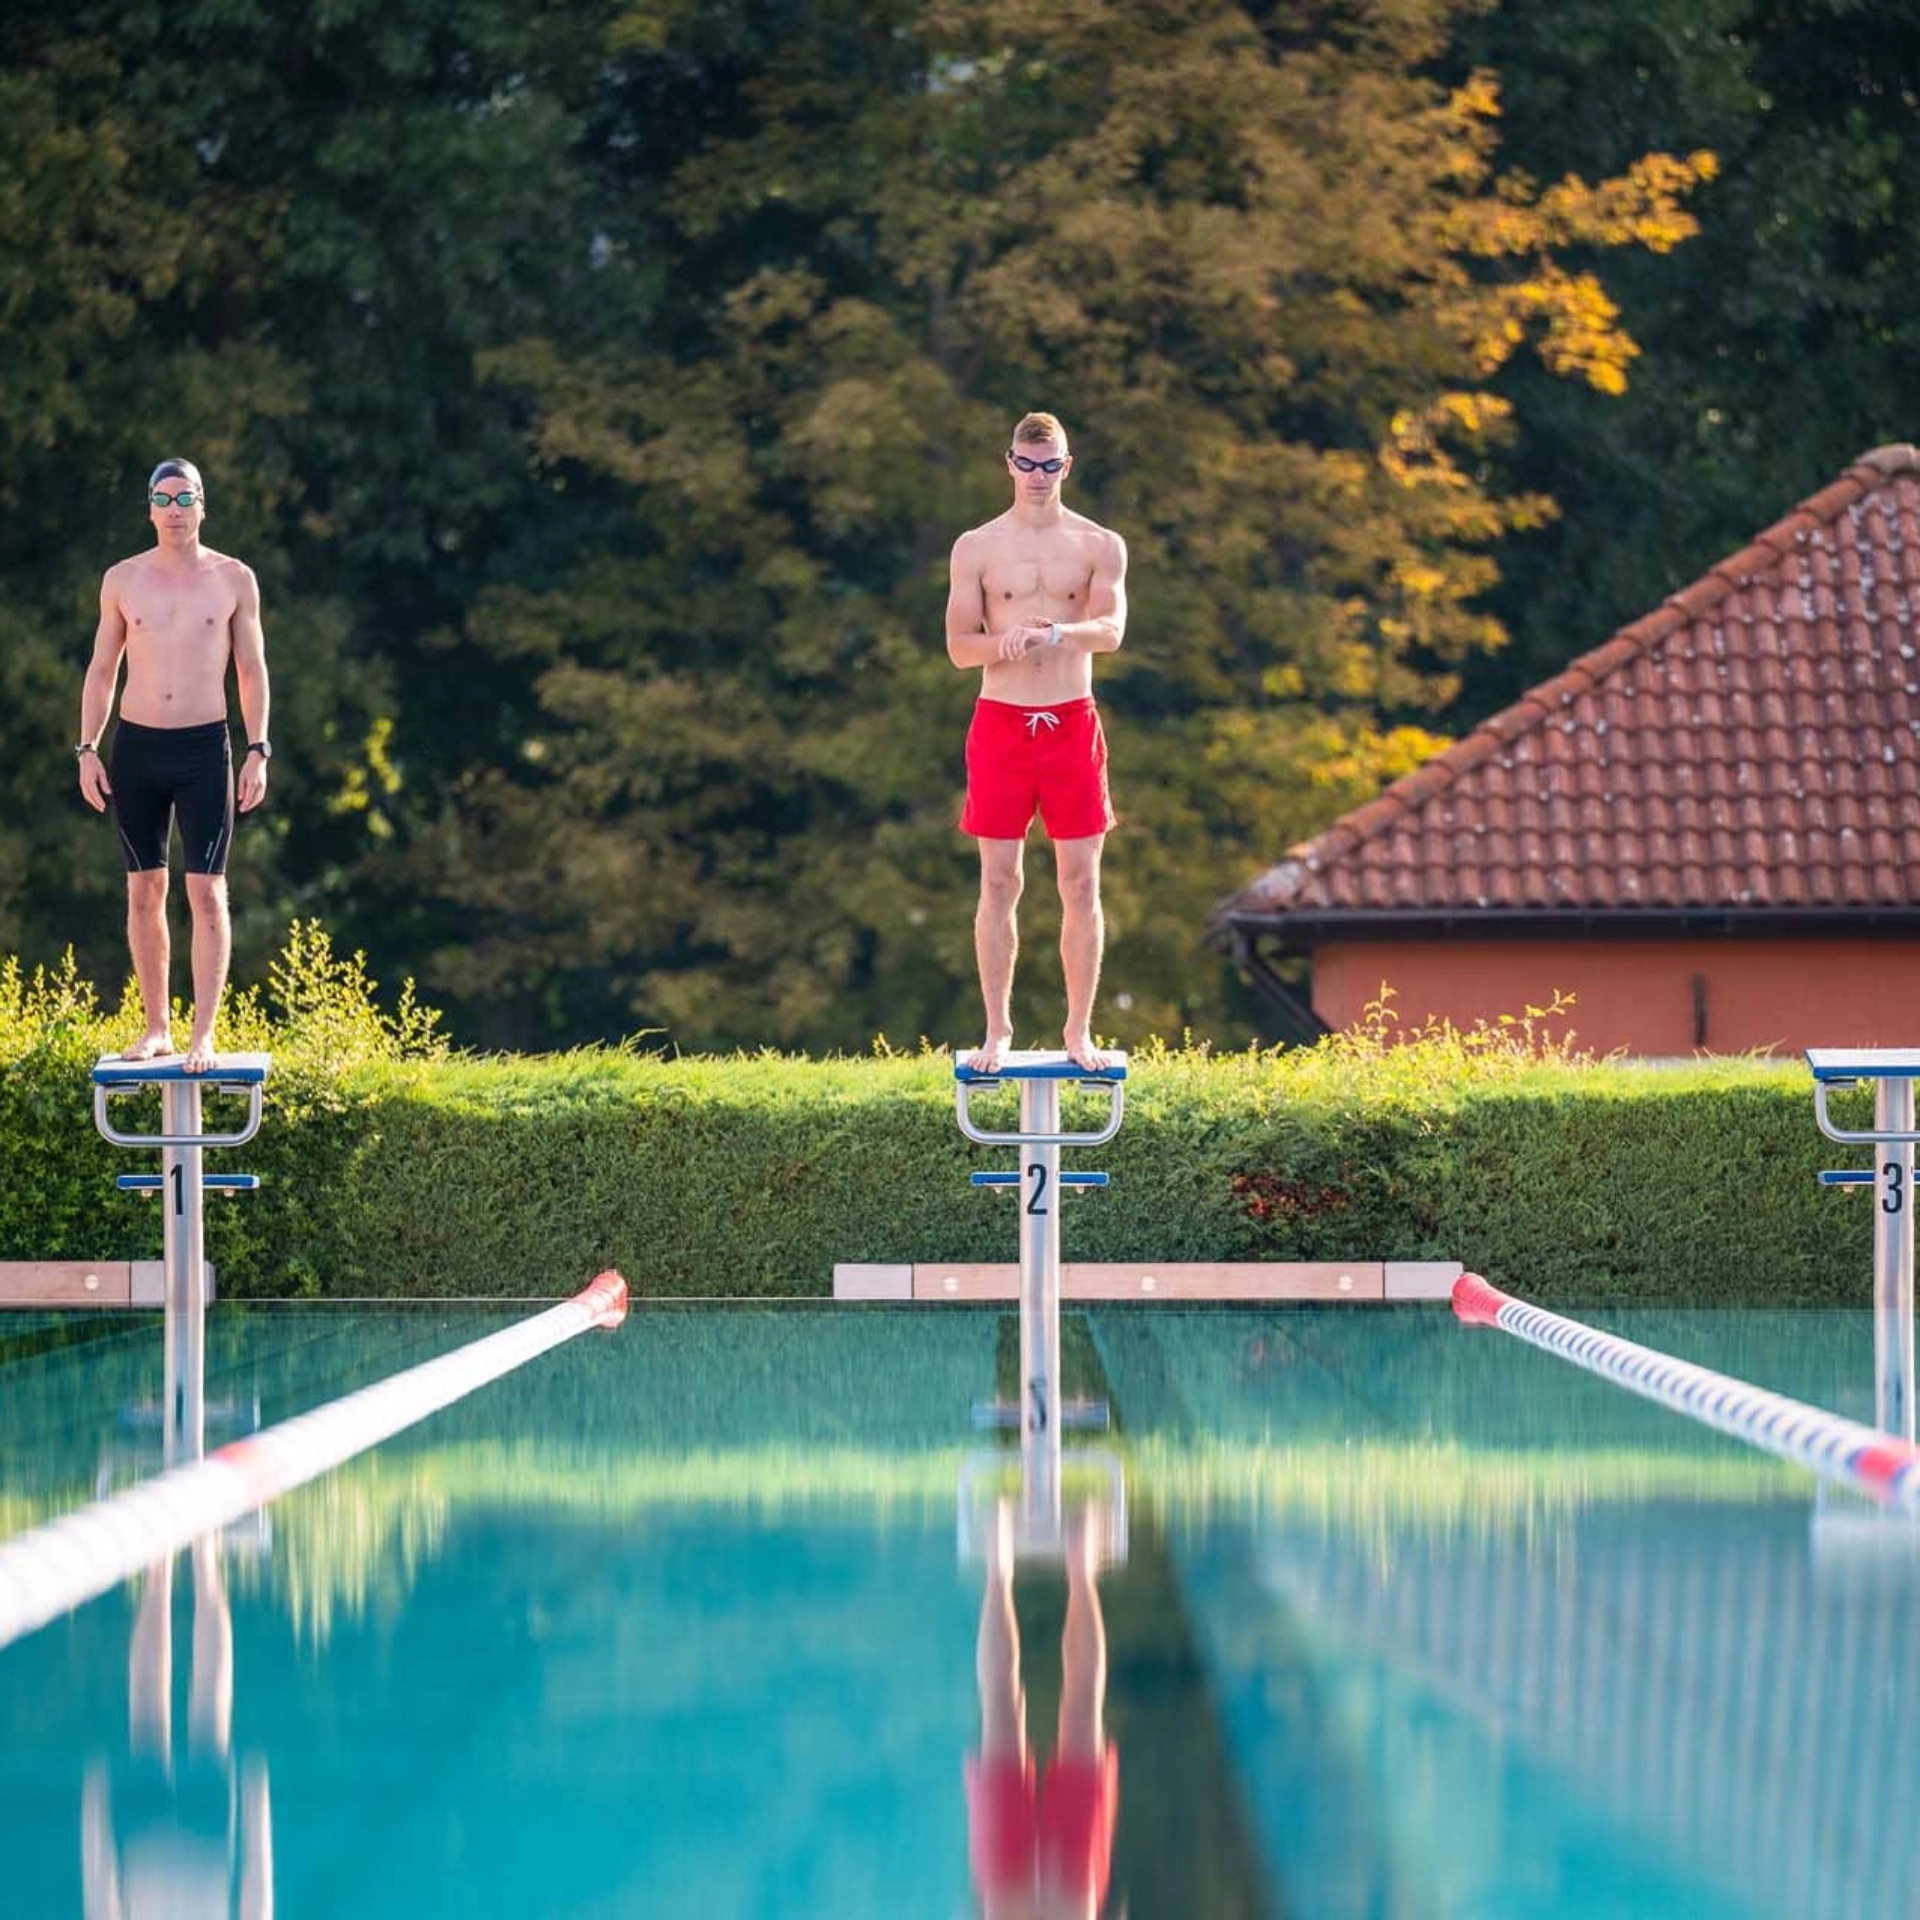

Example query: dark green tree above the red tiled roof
[1455,0,1920,718]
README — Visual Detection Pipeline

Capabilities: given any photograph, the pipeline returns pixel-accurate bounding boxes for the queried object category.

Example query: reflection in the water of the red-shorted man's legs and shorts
[966,1501,1119,1920]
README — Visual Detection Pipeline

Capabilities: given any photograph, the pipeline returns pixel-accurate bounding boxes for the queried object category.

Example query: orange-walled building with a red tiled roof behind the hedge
[1212,445,1920,1056]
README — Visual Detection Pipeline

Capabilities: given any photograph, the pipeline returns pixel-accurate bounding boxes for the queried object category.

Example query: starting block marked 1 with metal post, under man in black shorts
[94,1054,273,1467]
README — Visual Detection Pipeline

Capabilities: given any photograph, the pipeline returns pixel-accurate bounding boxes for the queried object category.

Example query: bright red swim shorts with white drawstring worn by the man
[960,697,1117,839]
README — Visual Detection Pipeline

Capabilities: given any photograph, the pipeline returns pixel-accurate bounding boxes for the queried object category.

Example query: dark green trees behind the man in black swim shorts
[0,0,647,1029]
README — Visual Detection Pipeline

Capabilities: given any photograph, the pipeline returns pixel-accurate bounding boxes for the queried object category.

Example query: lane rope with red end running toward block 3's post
[1453,1273,1920,1515]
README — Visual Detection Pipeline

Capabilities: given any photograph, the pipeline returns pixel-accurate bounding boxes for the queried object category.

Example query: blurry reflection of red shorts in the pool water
[966,1741,1119,1912]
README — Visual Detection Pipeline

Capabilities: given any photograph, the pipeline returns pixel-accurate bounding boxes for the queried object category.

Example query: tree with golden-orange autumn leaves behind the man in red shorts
[428,0,1711,1044]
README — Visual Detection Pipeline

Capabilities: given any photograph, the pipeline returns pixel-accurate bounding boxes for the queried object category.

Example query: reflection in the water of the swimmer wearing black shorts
[81,1534,273,1920]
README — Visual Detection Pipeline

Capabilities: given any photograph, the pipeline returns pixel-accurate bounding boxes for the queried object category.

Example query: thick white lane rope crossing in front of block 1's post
[0,1267,628,1647]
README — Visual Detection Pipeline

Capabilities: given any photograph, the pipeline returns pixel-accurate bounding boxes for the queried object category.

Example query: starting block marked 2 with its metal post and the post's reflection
[954,1052,1127,1555]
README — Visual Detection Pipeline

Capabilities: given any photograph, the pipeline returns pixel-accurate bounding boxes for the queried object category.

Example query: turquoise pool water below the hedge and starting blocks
[0,1308,1920,1920]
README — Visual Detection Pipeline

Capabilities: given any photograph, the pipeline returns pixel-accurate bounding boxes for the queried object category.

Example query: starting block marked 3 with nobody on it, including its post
[1807,1046,1920,1442]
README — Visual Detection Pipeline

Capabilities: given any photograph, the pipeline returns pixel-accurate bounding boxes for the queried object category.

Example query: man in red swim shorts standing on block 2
[947,413,1127,1071]
